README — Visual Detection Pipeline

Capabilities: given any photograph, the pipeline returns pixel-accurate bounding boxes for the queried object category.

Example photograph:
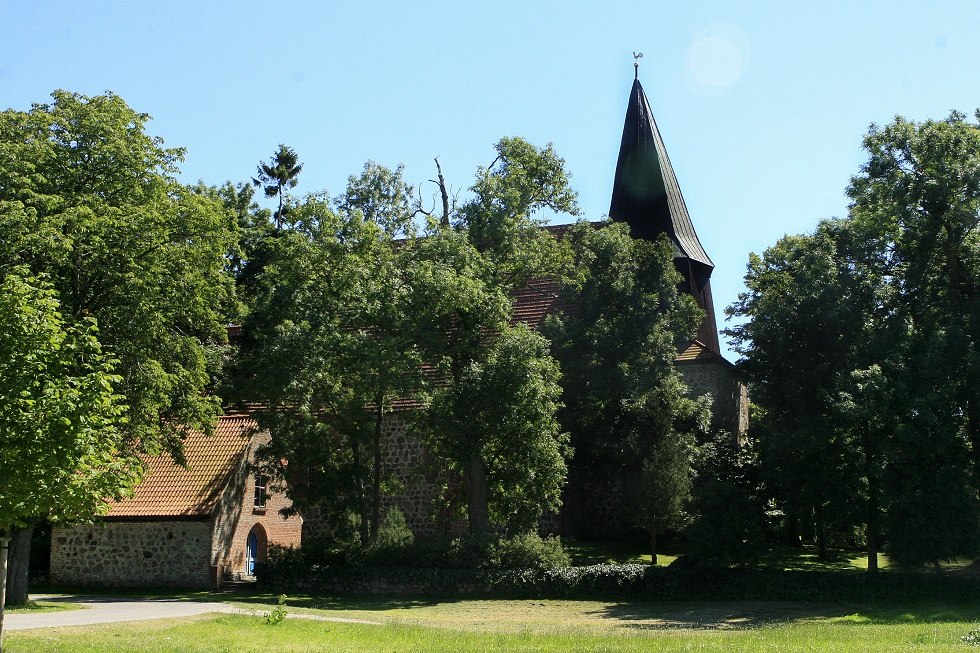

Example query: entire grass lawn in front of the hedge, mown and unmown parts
[5,596,980,653]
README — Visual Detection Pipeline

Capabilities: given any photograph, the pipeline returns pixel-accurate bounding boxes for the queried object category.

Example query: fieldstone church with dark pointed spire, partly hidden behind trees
[51,70,748,587]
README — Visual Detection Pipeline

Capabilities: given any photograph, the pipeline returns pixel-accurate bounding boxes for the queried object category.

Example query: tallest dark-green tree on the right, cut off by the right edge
[848,112,980,563]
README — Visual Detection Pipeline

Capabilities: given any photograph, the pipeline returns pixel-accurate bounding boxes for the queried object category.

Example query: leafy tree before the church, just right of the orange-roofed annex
[240,185,421,545]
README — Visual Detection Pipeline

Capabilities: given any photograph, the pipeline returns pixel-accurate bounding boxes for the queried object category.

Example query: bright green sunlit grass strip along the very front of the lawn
[6,615,976,653]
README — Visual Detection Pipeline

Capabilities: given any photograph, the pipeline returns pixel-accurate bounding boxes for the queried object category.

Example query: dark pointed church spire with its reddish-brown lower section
[609,74,721,355]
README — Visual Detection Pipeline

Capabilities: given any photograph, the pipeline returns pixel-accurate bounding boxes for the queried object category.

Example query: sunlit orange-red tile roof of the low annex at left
[106,415,255,518]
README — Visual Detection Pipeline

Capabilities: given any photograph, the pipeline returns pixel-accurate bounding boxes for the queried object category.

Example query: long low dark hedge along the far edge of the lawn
[257,564,980,602]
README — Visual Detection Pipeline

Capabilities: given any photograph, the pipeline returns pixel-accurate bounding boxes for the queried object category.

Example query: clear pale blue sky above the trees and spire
[0,0,980,356]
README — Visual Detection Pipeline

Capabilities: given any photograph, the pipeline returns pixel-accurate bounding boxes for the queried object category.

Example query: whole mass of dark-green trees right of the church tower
[729,113,980,569]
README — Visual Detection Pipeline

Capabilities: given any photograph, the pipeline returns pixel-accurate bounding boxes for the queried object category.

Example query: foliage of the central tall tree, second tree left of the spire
[401,139,577,534]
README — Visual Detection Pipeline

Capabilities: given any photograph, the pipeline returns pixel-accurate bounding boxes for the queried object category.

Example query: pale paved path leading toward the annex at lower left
[3,596,243,630]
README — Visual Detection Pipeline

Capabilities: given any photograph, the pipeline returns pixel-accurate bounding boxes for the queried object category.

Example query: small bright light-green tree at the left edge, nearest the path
[0,268,141,638]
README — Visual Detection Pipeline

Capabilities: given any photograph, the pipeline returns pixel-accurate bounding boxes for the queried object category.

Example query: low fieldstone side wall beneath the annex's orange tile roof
[51,521,211,589]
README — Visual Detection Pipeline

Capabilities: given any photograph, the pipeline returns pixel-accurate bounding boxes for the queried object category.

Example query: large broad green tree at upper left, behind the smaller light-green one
[0,91,237,600]
